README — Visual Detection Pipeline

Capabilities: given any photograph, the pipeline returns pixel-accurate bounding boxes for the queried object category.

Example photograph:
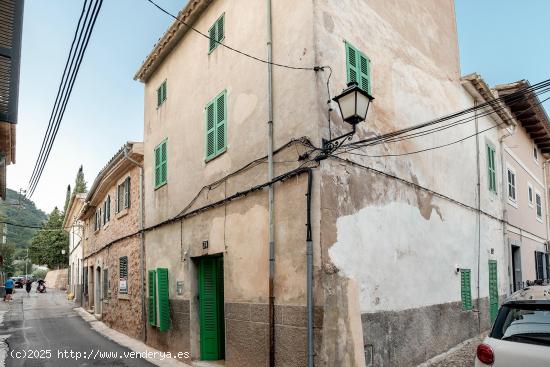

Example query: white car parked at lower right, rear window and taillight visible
[475,285,550,367]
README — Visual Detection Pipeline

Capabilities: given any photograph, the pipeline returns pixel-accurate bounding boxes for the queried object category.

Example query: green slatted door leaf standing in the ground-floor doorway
[199,258,220,361]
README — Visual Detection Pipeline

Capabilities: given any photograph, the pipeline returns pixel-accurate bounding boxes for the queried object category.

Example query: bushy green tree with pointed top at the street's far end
[29,207,69,269]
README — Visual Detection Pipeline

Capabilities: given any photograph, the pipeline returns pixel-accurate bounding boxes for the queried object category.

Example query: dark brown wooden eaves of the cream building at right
[494,80,550,154]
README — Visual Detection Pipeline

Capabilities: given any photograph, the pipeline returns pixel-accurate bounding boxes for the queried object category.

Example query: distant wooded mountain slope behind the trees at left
[0,189,48,249]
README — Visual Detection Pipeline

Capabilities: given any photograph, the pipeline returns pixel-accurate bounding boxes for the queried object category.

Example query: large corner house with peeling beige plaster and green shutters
[134,0,543,367]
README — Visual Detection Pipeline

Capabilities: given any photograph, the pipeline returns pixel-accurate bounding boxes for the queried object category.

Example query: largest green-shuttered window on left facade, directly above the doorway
[205,91,227,161]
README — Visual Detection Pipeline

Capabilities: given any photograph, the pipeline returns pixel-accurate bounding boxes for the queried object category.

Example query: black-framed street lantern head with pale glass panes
[334,83,374,125]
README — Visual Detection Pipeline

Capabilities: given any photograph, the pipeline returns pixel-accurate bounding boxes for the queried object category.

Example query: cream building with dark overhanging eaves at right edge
[495,80,550,290]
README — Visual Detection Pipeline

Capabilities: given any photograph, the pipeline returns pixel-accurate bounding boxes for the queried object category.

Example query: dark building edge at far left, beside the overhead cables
[0,0,24,199]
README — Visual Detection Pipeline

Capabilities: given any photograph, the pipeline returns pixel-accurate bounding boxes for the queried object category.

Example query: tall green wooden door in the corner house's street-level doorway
[199,257,225,361]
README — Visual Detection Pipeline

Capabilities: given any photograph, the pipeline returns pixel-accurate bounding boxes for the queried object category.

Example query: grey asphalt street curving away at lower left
[0,285,153,367]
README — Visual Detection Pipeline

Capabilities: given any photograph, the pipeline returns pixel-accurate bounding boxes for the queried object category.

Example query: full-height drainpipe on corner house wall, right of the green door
[266,0,275,367]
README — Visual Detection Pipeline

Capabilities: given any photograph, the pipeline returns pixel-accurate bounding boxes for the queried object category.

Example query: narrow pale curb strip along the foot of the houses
[73,307,192,367]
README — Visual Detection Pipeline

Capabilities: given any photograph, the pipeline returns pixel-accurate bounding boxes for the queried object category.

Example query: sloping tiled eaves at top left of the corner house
[134,0,214,83]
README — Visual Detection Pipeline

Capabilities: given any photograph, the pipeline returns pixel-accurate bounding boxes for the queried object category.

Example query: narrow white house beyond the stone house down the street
[63,193,86,304]
